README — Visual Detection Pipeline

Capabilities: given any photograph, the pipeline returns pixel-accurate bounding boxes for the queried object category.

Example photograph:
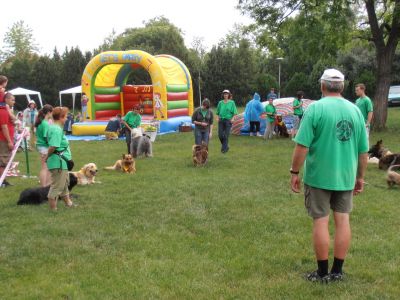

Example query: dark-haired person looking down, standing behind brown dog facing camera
[192,98,214,145]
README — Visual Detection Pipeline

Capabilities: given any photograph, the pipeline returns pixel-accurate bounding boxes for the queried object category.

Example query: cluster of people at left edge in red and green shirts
[0,75,74,210]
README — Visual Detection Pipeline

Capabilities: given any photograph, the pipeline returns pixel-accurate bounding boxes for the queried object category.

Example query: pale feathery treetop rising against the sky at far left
[0,20,38,62]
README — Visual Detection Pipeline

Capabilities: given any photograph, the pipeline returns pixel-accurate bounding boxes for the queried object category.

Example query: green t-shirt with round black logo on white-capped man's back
[294,97,368,191]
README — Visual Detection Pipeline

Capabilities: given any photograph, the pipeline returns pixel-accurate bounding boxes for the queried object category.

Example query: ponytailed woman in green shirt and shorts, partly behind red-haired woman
[35,104,53,186]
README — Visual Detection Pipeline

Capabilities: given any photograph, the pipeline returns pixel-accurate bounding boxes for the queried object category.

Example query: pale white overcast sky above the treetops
[0,0,251,55]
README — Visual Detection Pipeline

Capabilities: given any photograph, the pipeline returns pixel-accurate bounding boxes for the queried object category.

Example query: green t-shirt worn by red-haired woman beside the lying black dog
[47,124,72,170]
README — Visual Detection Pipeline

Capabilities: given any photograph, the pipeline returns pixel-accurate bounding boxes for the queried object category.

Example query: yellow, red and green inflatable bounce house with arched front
[72,50,193,135]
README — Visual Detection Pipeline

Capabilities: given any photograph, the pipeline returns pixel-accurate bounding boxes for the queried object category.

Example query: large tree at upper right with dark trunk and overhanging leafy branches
[239,0,400,129]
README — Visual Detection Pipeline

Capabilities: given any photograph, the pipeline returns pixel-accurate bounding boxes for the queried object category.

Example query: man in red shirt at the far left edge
[0,93,15,186]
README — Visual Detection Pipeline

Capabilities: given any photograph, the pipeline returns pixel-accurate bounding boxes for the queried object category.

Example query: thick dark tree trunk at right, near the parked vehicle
[372,47,395,130]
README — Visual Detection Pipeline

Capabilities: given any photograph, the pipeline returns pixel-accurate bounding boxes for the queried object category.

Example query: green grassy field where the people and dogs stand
[0,108,400,299]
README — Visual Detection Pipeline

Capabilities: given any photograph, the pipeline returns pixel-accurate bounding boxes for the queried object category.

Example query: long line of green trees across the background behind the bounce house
[0,0,400,127]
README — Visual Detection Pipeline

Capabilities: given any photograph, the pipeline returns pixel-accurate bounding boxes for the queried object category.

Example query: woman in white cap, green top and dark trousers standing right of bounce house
[217,90,238,153]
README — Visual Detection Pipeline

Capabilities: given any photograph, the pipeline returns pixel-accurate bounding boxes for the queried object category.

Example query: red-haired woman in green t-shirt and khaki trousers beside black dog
[44,107,75,211]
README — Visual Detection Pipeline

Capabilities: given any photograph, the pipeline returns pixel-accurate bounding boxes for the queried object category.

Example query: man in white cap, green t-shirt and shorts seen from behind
[290,69,368,283]
